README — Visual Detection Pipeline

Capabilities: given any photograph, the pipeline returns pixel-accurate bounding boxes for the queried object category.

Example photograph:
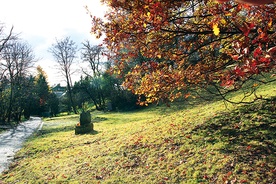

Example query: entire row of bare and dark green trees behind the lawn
[0,22,137,123]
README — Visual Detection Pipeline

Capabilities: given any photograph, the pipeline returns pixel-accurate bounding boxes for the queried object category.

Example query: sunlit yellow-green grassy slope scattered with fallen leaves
[0,84,276,183]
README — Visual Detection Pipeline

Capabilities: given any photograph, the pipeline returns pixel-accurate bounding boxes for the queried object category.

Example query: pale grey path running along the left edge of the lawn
[0,117,43,173]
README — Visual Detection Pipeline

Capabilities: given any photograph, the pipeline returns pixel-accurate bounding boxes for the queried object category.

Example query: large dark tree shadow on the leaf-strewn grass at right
[193,97,276,183]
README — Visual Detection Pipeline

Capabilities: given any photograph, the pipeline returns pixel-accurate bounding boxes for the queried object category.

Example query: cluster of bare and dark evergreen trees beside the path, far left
[0,25,58,123]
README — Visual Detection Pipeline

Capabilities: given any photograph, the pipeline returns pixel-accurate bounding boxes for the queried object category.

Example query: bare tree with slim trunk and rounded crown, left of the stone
[49,37,77,114]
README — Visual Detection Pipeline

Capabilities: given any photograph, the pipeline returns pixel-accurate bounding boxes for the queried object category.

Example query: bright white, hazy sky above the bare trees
[0,0,106,86]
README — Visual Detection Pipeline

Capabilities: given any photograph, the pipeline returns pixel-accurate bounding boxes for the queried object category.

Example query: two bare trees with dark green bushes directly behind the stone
[49,37,138,113]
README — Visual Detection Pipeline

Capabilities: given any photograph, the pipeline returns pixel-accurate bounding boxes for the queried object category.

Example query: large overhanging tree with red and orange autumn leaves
[91,0,276,104]
